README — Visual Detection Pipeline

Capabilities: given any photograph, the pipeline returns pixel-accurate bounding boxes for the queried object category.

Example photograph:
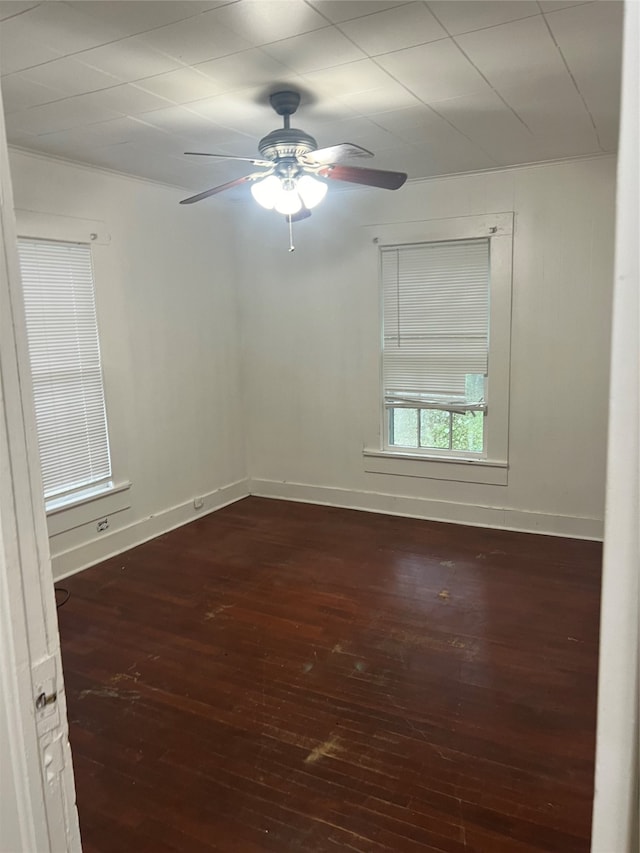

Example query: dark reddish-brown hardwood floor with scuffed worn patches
[59,498,601,853]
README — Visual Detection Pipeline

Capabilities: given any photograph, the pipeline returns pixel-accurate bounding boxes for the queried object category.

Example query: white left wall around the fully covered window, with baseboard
[11,151,246,577]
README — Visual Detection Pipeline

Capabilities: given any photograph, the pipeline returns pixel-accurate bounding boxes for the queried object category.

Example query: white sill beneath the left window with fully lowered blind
[45,481,131,536]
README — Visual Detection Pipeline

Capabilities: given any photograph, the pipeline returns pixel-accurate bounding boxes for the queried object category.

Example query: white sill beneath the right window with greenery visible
[362,449,509,486]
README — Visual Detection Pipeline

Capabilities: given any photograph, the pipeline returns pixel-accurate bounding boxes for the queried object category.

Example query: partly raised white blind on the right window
[381,238,489,411]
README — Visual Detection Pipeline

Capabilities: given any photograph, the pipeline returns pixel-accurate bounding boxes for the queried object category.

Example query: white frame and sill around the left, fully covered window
[15,209,131,536]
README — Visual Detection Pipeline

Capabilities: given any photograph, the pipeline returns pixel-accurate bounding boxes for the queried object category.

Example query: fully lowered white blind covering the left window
[18,238,111,499]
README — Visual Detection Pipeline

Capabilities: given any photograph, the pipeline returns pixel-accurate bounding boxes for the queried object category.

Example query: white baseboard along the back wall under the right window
[249,479,604,541]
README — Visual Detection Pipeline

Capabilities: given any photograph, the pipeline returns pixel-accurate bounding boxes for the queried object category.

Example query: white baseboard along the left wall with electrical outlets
[51,480,249,581]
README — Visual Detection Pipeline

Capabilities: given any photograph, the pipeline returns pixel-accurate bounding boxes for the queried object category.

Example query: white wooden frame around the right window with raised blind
[363,212,514,485]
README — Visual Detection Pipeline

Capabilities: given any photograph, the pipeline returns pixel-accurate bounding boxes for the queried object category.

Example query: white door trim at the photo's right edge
[591,3,640,853]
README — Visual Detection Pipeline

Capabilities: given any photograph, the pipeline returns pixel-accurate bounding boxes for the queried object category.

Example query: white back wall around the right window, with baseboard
[240,158,615,537]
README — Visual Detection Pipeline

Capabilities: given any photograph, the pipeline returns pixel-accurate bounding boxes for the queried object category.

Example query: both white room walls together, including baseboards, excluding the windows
[12,151,615,577]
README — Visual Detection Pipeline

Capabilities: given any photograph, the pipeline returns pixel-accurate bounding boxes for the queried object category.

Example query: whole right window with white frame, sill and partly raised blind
[363,213,513,485]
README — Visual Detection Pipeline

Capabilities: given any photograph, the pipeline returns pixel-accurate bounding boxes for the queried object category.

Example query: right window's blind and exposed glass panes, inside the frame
[381,238,489,456]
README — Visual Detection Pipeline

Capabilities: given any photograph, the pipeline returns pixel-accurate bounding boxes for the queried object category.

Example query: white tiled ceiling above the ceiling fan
[0,0,622,190]
